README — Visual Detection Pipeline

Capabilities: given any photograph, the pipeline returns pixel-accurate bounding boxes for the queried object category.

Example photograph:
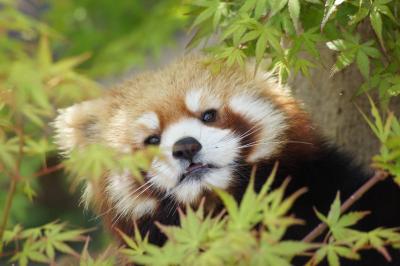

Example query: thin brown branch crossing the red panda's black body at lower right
[302,170,388,242]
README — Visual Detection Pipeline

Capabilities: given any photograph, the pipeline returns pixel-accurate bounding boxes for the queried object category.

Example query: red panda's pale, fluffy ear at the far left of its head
[53,99,106,153]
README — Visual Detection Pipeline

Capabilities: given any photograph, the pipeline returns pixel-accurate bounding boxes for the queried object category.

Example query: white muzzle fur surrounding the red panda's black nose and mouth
[149,118,240,203]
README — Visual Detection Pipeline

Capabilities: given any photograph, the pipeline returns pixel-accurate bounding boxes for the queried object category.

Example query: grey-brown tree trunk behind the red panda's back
[290,48,400,165]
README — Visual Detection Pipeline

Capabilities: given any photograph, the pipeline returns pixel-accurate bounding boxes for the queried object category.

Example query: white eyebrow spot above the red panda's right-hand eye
[185,89,222,113]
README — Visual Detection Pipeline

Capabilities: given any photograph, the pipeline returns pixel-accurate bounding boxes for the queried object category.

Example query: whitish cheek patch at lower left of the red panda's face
[106,172,157,219]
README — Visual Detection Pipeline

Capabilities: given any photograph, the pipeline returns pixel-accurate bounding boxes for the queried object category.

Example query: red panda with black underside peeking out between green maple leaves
[54,56,400,265]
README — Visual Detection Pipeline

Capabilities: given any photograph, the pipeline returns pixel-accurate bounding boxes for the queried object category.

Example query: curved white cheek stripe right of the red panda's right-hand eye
[229,94,288,163]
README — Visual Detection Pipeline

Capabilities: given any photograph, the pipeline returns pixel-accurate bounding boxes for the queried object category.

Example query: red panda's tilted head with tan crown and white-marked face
[55,57,312,222]
